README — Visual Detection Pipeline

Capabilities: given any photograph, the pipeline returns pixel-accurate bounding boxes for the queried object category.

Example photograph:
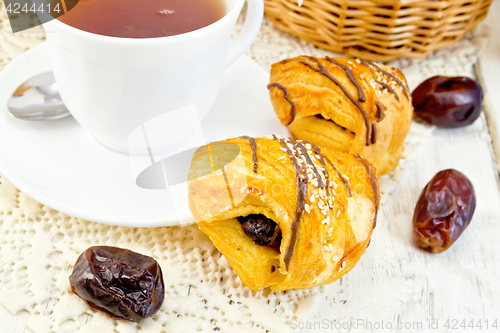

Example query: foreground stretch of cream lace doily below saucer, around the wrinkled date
[0,178,319,333]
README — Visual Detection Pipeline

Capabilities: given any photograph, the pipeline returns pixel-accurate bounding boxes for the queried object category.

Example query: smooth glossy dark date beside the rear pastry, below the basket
[412,76,483,128]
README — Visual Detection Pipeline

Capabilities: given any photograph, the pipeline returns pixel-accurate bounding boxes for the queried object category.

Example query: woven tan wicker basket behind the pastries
[264,0,492,61]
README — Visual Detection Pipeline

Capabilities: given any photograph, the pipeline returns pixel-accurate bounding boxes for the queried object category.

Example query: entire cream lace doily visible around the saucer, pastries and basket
[0,4,488,333]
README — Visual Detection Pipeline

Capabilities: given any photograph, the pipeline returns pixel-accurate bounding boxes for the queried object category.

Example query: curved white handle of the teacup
[226,0,264,67]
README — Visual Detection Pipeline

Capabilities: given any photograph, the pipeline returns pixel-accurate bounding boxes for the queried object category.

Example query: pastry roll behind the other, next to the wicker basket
[268,57,413,175]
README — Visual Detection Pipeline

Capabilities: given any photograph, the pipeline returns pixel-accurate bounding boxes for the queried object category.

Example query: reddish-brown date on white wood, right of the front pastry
[413,169,476,253]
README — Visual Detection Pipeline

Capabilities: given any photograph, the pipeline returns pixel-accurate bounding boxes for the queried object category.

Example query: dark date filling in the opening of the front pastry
[238,214,281,249]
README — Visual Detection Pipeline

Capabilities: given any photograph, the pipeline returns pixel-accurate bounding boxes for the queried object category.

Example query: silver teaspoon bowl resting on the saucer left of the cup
[7,72,70,121]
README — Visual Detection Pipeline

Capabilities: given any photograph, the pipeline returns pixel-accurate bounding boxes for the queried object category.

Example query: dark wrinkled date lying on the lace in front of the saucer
[69,246,165,321]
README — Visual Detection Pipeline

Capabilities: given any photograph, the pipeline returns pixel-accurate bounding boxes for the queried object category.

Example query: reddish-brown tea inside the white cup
[58,0,226,38]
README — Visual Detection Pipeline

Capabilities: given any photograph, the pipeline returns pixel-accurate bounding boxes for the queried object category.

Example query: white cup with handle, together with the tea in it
[44,0,263,153]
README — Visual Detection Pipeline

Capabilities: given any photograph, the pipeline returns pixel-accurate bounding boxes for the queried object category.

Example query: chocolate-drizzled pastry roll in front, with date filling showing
[188,136,379,291]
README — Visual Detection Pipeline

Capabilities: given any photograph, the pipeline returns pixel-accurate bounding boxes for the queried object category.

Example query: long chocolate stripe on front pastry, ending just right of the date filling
[273,135,307,269]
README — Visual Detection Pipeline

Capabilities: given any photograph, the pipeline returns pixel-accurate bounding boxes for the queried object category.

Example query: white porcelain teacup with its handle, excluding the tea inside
[44,0,264,152]
